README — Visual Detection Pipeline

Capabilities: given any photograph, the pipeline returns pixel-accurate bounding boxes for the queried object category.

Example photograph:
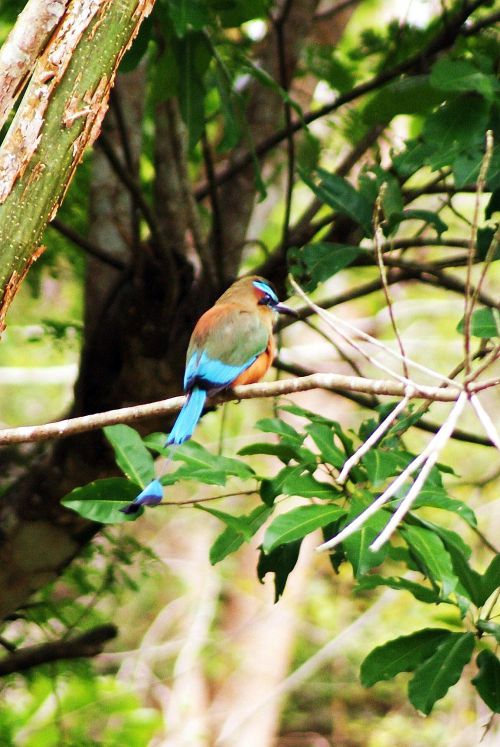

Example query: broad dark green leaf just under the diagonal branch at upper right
[363,75,444,125]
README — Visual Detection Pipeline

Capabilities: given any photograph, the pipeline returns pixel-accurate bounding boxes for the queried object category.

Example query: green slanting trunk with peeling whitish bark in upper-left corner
[0,0,152,330]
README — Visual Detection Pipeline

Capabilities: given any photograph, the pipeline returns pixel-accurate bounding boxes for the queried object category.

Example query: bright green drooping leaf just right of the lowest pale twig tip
[400,526,458,599]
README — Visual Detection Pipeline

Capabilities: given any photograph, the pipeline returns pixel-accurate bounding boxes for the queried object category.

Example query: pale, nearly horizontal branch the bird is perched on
[0,373,480,444]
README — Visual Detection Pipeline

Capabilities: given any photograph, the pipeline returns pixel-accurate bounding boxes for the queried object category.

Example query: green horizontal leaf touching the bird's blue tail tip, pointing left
[61,477,144,524]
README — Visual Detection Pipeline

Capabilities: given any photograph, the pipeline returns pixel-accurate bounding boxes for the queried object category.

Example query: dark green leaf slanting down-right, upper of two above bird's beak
[301,169,372,236]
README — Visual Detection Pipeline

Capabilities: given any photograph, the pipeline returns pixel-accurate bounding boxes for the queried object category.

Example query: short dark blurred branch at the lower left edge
[0,625,118,677]
